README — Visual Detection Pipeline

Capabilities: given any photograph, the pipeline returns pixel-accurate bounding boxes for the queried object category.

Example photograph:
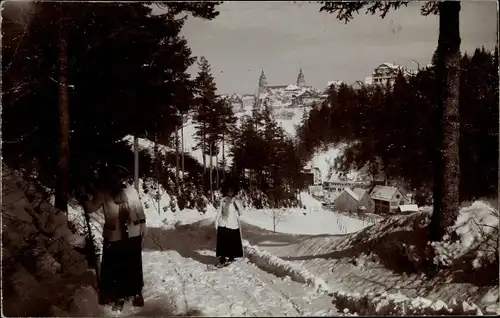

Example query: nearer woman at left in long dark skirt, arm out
[77,167,146,310]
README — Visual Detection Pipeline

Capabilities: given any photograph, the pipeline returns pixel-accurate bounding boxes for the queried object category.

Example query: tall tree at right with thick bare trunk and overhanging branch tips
[320,1,461,241]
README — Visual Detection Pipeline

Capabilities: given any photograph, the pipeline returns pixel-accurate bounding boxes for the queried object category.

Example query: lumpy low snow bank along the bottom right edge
[333,291,498,316]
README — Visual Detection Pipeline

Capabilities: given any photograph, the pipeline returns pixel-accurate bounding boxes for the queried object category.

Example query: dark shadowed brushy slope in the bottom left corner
[2,165,99,317]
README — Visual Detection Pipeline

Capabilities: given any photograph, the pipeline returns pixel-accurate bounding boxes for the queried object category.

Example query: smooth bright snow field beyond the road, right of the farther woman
[241,208,372,235]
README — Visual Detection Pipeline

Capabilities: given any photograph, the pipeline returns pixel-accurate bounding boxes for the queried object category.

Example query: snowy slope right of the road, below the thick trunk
[253,202,499,315]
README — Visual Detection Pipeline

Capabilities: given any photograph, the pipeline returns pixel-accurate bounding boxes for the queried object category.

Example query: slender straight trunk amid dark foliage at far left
[55,13,69,213]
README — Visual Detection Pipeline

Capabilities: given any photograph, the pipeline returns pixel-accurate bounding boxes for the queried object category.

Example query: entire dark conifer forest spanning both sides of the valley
[2,2,498,210]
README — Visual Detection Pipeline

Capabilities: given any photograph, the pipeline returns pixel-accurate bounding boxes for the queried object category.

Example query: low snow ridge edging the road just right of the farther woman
[243,240,330,293]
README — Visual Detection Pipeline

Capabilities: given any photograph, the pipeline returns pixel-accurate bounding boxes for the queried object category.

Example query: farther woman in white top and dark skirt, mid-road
[215,182,243,265]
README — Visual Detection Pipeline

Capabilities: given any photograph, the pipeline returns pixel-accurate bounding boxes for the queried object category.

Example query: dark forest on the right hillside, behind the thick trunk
[298,48,498,204]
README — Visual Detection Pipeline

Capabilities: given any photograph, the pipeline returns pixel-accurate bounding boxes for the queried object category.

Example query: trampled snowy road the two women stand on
[101,228,336,316]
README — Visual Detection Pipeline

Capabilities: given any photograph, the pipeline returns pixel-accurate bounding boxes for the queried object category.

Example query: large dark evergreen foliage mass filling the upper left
[2,2,218,209]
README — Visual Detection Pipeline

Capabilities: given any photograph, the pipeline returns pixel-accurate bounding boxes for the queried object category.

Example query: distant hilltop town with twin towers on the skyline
[223,63,422,113]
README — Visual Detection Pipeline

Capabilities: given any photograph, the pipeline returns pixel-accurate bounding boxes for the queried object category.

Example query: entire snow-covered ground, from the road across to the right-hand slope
[67,176,499,316]
